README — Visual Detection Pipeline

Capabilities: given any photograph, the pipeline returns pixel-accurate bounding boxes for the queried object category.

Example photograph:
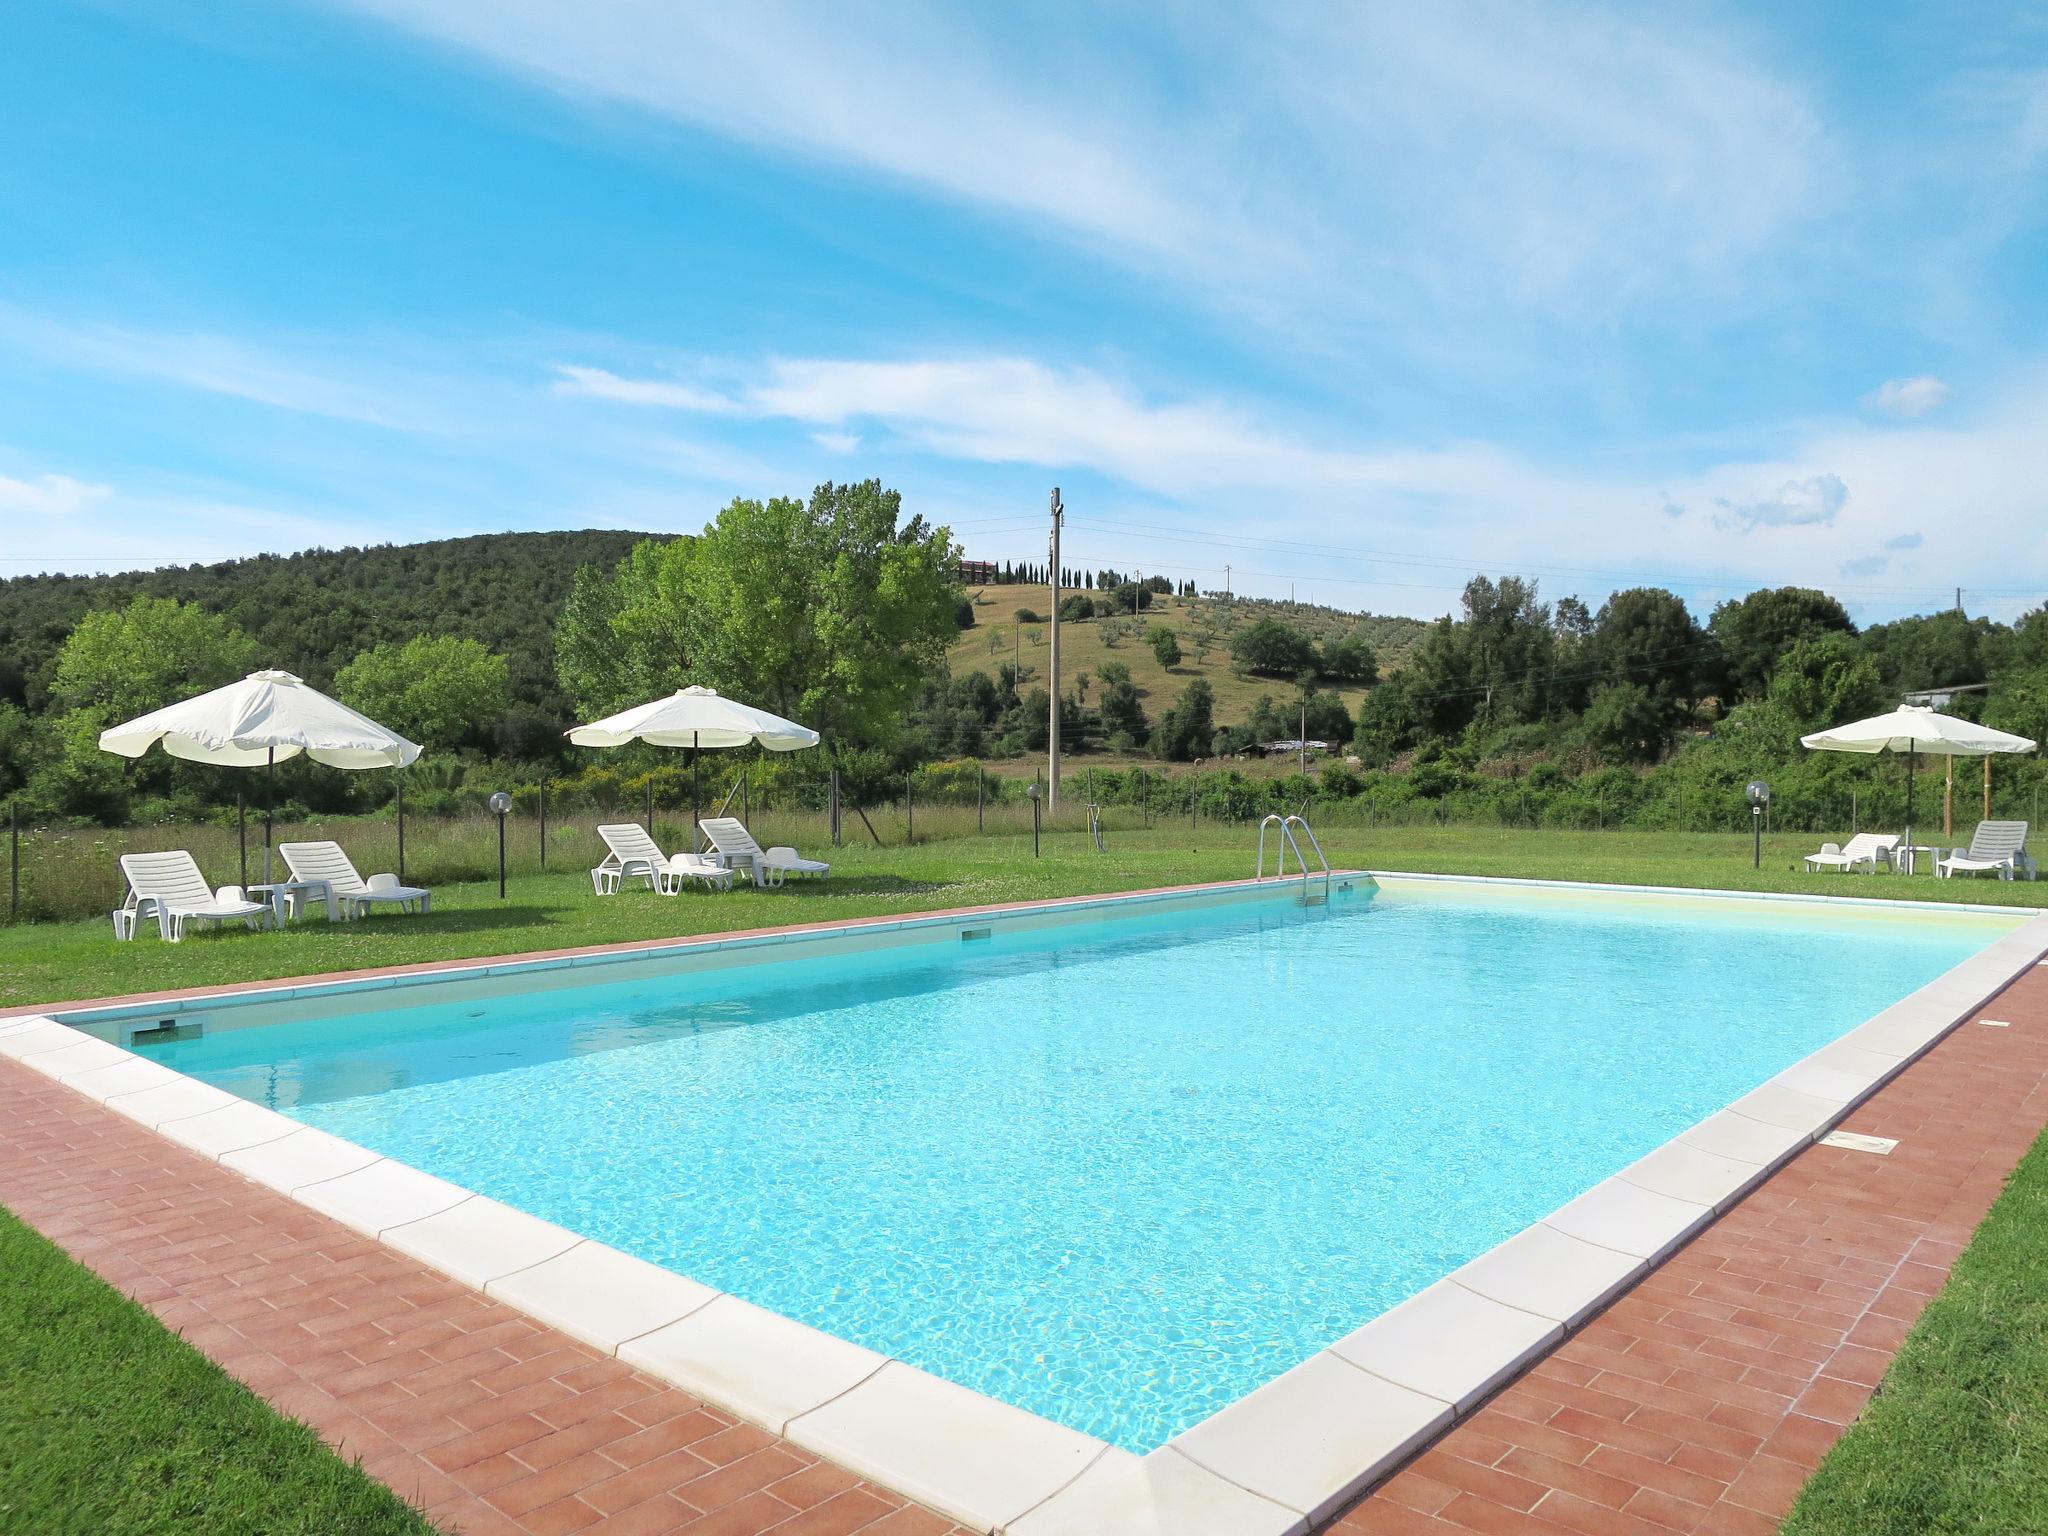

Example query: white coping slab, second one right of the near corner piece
[1329,1280,1565,1413]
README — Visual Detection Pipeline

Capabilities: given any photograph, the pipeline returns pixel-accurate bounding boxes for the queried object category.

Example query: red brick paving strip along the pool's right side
[1329,967,2048,1536]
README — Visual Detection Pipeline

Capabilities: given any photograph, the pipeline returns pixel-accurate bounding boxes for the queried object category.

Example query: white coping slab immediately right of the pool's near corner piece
[1169,1350,1452,1524]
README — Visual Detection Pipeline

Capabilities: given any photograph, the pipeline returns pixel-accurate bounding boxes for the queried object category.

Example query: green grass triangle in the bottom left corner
[0,1210,434,1536]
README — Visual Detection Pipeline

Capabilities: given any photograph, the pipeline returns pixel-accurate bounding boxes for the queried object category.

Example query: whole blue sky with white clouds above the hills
[0,0,2048,621]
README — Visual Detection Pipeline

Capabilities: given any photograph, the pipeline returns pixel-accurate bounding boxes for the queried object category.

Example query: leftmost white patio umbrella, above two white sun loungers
[100,672,420,883]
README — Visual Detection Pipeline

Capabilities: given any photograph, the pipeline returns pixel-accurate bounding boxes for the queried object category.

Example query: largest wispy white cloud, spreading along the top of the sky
[334,0,1827,352]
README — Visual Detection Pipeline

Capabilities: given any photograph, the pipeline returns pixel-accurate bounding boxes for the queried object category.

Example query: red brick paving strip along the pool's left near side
[0,1059,967,1536]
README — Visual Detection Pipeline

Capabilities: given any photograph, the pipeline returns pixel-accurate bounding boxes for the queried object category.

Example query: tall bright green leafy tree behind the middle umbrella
[557,481,958,745]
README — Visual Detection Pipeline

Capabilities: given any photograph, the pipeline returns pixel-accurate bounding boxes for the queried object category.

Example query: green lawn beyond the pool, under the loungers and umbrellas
[0,821,2048,1008]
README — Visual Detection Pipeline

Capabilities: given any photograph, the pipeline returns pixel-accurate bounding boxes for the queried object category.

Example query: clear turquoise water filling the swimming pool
[152,887,2011,1452]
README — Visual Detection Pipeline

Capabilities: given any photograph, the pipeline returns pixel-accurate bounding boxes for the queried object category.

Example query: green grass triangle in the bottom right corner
[1784,1137,2048,1536]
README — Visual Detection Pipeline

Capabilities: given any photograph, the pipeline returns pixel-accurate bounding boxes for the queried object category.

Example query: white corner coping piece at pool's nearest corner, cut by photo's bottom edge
[1004,1448,1309,1536]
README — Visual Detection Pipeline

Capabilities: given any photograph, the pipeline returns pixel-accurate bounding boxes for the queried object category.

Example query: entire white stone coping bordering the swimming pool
[16,870,2048,1536]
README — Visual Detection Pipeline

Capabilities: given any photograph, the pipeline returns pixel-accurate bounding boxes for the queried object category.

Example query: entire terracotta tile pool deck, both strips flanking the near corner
[0,967,2048,1536]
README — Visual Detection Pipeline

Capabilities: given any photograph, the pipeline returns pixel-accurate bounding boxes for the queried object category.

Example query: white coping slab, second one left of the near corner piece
[618,1296,887,1434]
